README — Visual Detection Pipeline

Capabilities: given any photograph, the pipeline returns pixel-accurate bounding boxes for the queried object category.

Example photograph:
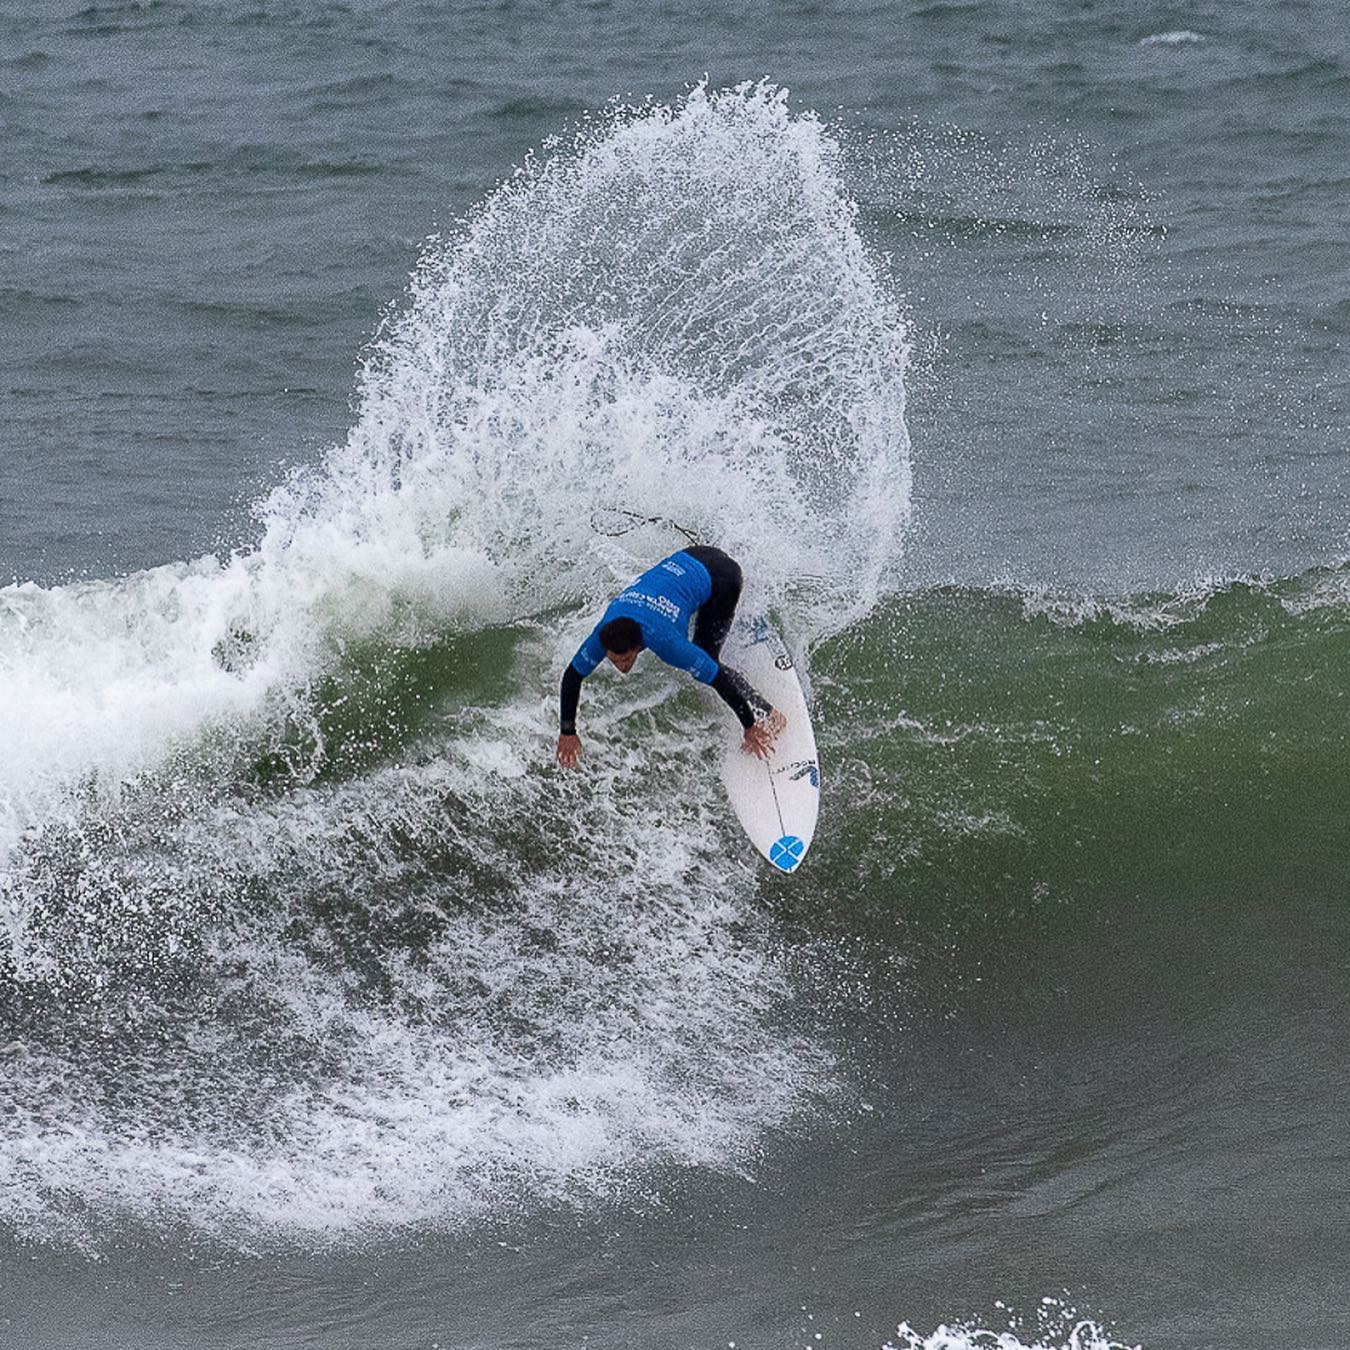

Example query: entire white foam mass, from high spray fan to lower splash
[0,86,909,1246]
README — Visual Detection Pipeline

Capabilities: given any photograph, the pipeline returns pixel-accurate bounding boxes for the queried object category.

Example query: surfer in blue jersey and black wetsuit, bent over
[558,544,784,768]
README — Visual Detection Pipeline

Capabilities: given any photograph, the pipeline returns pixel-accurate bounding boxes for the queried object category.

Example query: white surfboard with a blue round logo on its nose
[722,617,821,872]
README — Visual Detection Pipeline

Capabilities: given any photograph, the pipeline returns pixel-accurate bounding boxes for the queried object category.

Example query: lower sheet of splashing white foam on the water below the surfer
[0,752,828,1247]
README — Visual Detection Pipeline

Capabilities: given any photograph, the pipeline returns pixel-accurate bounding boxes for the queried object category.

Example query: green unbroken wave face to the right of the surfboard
[814,572,1350,926]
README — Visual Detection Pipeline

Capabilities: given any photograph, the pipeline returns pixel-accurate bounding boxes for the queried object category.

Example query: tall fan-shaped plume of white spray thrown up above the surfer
[325,78,910,618]
